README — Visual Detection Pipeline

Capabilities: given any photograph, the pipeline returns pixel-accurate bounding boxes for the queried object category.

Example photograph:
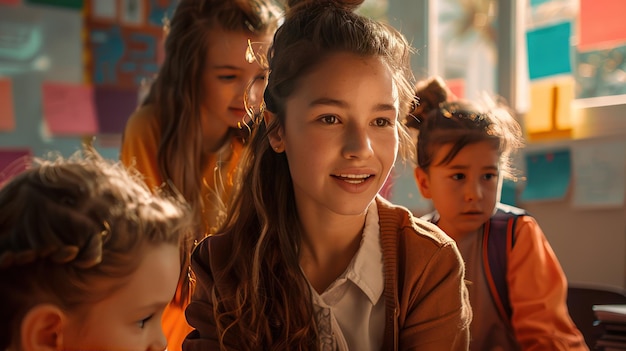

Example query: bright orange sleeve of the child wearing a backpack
[507,216,588,351]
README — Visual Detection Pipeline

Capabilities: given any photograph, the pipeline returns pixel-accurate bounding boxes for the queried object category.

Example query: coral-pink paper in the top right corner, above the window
[578,0,626,51]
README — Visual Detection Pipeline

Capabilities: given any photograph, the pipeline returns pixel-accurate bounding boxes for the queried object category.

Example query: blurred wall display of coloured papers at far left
[0,0,177,182]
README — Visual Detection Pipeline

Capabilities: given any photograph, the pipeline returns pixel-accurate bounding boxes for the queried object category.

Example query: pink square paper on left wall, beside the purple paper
[42,83,98,135]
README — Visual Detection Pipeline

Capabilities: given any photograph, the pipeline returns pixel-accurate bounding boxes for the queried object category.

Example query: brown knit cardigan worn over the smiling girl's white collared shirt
[183,196,472,351]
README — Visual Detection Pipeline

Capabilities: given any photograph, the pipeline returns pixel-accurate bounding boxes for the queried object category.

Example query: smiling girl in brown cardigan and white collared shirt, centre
[183,0,471,351]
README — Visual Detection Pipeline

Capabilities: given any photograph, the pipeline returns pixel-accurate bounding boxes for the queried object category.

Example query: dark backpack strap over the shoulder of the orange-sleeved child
[483,203,527,321]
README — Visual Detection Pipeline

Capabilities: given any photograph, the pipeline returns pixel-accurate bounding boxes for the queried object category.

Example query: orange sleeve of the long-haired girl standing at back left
[120,106,163,189]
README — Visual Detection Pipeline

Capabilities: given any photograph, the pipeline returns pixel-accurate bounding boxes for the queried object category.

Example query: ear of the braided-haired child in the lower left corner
[20,304,65,351]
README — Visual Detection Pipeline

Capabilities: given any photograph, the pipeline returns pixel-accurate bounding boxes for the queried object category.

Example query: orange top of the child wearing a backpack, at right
[457,216,588,351]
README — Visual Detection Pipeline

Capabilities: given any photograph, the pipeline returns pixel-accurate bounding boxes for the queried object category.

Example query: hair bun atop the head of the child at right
[406,76,454,129]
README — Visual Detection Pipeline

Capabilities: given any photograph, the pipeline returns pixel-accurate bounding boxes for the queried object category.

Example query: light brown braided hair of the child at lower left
[0,151,191,349]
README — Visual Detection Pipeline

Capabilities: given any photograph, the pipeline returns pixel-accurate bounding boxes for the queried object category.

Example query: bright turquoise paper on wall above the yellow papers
[526,22,572,79]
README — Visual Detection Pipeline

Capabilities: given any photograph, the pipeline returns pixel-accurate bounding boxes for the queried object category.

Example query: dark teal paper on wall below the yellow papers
[520,149,572,201]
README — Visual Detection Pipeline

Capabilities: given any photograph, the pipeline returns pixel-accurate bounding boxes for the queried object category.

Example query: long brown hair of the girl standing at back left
[143,0,280,305]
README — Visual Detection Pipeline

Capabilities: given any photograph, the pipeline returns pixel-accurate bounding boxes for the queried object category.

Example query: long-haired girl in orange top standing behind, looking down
[121,0,280,351]
